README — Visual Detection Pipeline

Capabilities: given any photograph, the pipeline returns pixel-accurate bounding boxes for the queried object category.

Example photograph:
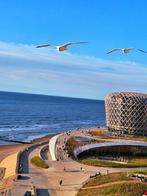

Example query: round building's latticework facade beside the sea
[105,92,147,135]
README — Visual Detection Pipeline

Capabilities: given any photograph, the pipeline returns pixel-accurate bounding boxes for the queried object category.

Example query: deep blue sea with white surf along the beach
[0,92,105,144]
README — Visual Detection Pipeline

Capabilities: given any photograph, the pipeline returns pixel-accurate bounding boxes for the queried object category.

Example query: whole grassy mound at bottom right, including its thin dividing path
[77,170,147,196]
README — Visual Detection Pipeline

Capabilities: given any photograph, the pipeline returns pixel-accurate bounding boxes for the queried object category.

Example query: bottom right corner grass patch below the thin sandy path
[77,181,147,196]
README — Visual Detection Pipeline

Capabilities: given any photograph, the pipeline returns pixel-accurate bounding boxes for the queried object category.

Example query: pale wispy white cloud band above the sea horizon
[0,42,147,99]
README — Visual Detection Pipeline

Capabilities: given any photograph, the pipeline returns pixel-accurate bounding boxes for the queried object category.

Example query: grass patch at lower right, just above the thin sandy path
[83,172,132,187]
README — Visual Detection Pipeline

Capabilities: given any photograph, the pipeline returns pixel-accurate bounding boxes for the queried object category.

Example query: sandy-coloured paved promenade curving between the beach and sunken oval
[12,132,147,196]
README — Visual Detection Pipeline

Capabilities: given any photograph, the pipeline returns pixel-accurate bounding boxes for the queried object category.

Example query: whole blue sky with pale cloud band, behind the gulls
[0,0,147,99]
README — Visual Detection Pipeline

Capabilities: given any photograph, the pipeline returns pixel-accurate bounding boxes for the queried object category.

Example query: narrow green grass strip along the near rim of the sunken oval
[79,159,147,168]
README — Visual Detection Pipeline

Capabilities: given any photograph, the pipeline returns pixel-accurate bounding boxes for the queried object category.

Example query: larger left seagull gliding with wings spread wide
[36,42,88,52]
